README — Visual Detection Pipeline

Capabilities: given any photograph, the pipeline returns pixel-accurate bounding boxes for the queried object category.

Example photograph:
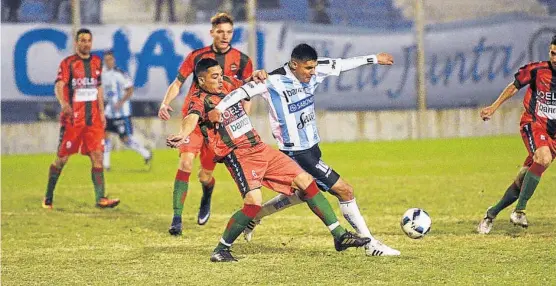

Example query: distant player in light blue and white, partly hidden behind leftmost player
[102,51,152,170]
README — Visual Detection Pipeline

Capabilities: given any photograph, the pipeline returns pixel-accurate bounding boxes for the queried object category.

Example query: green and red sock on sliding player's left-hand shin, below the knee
[215,204,261,251]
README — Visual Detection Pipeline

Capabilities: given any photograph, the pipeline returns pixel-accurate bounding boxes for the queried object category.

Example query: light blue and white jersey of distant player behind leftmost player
[102,67,133,118]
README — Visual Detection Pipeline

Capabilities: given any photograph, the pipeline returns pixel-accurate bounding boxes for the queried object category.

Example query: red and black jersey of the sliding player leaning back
[187,76,261,160]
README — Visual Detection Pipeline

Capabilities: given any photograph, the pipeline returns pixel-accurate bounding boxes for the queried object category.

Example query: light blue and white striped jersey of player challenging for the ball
[251,59,341,151]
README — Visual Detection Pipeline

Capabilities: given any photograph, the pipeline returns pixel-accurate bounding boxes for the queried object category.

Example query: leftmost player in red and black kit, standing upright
[42,29,120,209]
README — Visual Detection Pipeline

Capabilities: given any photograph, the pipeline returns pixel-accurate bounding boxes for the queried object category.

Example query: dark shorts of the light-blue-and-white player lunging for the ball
[281,144,340,192]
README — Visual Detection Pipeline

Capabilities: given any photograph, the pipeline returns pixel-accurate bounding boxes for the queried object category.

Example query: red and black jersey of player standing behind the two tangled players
[176,45,253,114]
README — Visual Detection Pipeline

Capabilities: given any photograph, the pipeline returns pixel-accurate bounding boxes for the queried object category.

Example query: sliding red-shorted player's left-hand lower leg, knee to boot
[210,189,262,262]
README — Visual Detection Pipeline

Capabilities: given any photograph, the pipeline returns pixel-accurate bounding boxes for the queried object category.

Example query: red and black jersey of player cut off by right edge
[514,61,556,138]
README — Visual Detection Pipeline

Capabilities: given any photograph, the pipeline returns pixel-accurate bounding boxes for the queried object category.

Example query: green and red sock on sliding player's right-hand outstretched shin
[303,180,346,240]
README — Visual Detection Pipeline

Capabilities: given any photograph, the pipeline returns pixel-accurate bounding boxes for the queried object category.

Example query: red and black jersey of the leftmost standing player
[56,54,102,126]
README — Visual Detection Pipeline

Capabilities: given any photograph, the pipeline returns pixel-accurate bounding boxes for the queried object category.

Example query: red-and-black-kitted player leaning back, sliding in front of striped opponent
[167,59,370,262]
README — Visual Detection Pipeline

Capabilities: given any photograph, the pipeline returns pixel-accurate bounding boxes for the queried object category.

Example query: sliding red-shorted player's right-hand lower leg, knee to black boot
[294,173,371,251]
